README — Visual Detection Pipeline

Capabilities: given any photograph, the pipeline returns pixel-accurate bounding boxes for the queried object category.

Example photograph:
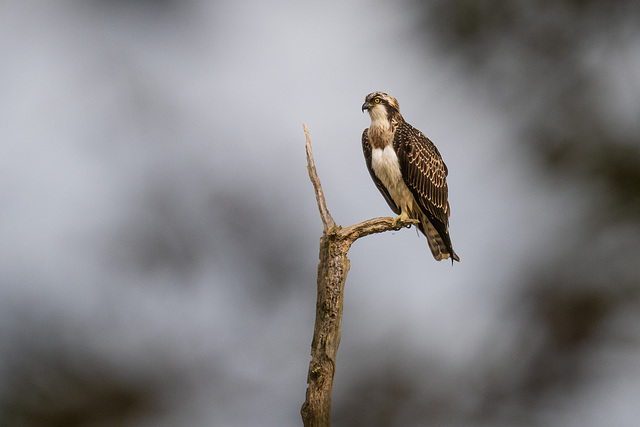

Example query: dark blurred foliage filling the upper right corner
[419,0,640,216]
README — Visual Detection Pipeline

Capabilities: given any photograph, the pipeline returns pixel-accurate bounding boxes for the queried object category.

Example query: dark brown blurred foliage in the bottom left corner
[0,324,160,427]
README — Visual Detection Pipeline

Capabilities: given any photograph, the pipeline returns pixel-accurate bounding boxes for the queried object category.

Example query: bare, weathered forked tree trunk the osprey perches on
[300,125,417,427]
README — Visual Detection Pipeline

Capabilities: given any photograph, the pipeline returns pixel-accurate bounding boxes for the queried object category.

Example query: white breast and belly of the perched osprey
[371,145,414,212]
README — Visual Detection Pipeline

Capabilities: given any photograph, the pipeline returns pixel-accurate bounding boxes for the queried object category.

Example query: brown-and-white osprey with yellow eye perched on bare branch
[362,92,460,262]
